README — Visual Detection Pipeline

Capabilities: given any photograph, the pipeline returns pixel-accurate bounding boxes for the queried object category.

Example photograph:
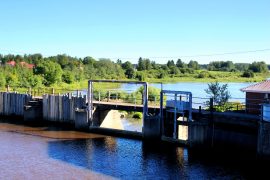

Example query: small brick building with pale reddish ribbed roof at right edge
[241,80,270,114]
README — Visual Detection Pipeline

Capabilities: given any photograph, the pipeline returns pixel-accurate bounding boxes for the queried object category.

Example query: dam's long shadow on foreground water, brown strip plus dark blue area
[0,118,269,179]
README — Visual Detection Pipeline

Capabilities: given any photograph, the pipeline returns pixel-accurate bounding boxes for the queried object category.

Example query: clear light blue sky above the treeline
[0,0,270,64]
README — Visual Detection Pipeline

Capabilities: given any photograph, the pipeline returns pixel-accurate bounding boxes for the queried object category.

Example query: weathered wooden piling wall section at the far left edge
[0,92,32,116]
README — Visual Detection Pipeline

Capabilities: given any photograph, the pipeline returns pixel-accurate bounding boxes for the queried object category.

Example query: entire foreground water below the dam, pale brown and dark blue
[0,122,269,180]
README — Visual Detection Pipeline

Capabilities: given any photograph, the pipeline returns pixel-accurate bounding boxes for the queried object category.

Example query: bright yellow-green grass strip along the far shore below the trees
[0,70,270,94]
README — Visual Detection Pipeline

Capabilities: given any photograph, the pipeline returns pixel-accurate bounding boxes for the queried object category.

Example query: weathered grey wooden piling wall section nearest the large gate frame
[43,94,86,123]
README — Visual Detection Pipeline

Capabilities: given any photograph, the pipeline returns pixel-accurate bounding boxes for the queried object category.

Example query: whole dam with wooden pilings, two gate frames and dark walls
[0,80,270,158]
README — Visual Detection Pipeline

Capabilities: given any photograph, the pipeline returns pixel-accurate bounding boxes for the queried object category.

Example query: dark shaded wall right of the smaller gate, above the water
[189,113,259,152]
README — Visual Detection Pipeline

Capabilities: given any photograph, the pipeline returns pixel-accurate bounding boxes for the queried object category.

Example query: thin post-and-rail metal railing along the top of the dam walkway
[0,86,265,114]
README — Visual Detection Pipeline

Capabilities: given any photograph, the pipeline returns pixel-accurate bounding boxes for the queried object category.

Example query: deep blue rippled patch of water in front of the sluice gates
[48,137,266,179]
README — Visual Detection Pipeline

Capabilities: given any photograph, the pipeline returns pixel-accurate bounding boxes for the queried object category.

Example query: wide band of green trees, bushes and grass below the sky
[0,54,269,89]
